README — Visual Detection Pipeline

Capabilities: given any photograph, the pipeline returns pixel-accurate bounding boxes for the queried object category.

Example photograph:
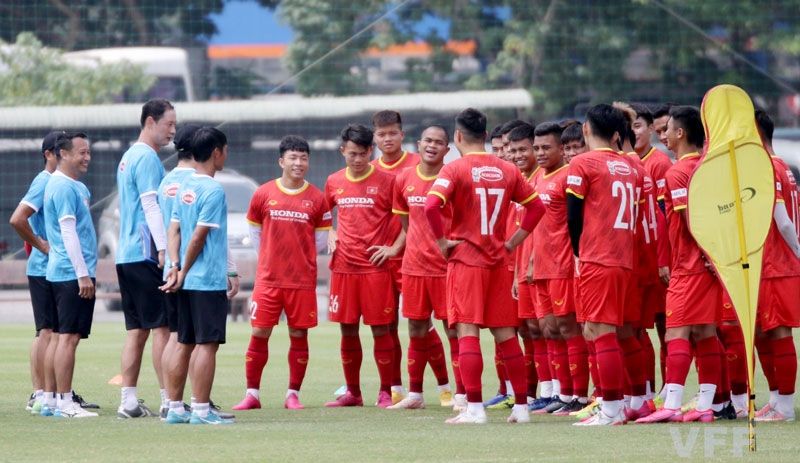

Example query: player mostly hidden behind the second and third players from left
[372,110,418,403]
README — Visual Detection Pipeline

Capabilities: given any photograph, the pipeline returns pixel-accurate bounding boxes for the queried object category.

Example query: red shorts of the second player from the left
[328,272,396,325]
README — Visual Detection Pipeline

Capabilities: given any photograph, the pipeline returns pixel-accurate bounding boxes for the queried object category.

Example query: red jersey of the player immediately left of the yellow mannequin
[664,153,708,276]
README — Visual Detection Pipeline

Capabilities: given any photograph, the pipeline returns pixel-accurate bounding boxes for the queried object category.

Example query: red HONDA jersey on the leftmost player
[247,180,331,289]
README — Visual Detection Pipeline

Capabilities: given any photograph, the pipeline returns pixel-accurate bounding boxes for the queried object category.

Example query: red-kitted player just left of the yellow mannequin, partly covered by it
[636,106,722,423]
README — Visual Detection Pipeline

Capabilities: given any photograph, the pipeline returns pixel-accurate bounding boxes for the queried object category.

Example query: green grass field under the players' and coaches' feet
[0,323,800,463]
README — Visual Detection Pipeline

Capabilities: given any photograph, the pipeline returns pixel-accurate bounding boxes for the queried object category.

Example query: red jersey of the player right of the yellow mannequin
[761,156,800,278]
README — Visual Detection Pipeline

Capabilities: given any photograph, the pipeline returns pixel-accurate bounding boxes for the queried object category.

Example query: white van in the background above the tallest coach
[64,47,195,101]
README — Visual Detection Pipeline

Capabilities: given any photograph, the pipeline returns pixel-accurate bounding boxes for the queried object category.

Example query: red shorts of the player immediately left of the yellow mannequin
[666,272,722,328]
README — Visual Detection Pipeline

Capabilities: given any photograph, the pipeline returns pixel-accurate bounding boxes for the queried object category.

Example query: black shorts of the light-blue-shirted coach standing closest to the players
[178,290,228,344]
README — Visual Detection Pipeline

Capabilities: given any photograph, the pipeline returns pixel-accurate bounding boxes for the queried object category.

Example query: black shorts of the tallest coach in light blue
[117,262,167,330]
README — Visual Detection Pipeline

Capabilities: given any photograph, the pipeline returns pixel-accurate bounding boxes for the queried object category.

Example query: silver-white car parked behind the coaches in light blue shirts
[97,170,259,313]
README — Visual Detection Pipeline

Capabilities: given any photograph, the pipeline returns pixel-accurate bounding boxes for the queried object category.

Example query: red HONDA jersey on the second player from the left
[325,166,398,273]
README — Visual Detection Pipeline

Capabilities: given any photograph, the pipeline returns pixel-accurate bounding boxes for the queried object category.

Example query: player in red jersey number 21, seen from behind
[567,104,639,426]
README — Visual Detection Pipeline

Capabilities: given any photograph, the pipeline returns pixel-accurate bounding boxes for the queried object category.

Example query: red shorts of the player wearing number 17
[447,262,519,328]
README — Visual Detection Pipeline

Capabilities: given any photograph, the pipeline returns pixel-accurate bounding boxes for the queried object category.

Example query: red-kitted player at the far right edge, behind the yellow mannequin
[744,110,800,421]
